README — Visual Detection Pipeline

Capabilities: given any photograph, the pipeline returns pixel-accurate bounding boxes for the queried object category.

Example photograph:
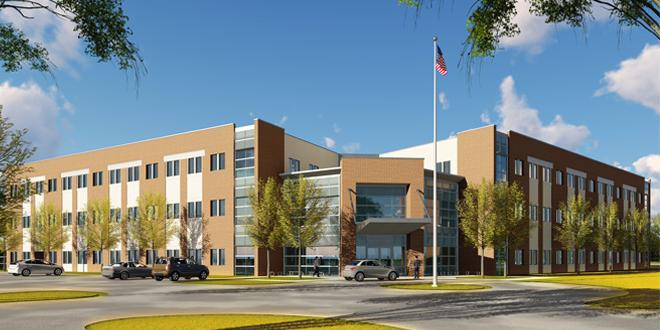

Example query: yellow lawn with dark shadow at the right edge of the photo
[529,272,660,309]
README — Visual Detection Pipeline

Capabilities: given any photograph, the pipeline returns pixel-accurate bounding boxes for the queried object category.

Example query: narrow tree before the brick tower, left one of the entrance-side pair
[248,177,282,278]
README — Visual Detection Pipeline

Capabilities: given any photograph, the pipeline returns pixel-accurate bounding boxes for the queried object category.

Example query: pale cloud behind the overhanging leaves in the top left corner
[0,1,83,75]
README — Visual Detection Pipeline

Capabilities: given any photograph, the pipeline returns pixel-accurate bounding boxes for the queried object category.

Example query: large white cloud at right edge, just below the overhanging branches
[595,44,660,114]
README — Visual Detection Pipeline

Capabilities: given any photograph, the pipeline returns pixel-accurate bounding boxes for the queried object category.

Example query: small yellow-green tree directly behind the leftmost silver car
[30,204,69,261]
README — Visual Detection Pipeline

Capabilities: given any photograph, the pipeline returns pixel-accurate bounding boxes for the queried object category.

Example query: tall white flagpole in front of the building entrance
[431,36,438,288]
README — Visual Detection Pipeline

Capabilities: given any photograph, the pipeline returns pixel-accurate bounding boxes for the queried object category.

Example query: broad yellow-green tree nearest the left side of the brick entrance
[277,176,330,278]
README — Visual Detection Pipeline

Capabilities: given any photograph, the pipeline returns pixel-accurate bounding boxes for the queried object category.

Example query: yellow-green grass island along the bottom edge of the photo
[85,314,399,330]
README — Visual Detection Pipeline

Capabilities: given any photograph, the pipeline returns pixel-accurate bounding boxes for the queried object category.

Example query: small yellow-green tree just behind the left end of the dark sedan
[78,198,121,266]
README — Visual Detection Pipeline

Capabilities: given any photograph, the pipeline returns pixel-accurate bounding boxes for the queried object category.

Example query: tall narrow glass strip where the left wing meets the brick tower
[234,128,254,275]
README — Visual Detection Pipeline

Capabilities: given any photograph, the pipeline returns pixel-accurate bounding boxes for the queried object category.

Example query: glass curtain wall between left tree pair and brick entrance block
[284,174,339,276]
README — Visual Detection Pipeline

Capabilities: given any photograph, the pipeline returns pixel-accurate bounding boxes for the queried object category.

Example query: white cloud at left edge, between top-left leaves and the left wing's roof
[0,81,73,158]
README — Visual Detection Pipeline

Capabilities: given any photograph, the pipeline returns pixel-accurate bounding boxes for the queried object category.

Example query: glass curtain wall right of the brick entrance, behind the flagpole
[424,176,458,275]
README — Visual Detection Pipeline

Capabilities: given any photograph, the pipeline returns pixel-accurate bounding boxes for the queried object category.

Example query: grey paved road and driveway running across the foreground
[0,274,660,330]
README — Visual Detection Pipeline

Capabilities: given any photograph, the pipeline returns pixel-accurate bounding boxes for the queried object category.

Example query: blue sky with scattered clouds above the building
[0,0,660,211]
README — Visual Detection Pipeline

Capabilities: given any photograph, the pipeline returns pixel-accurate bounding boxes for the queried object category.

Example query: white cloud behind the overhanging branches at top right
[500,0,553,54]
